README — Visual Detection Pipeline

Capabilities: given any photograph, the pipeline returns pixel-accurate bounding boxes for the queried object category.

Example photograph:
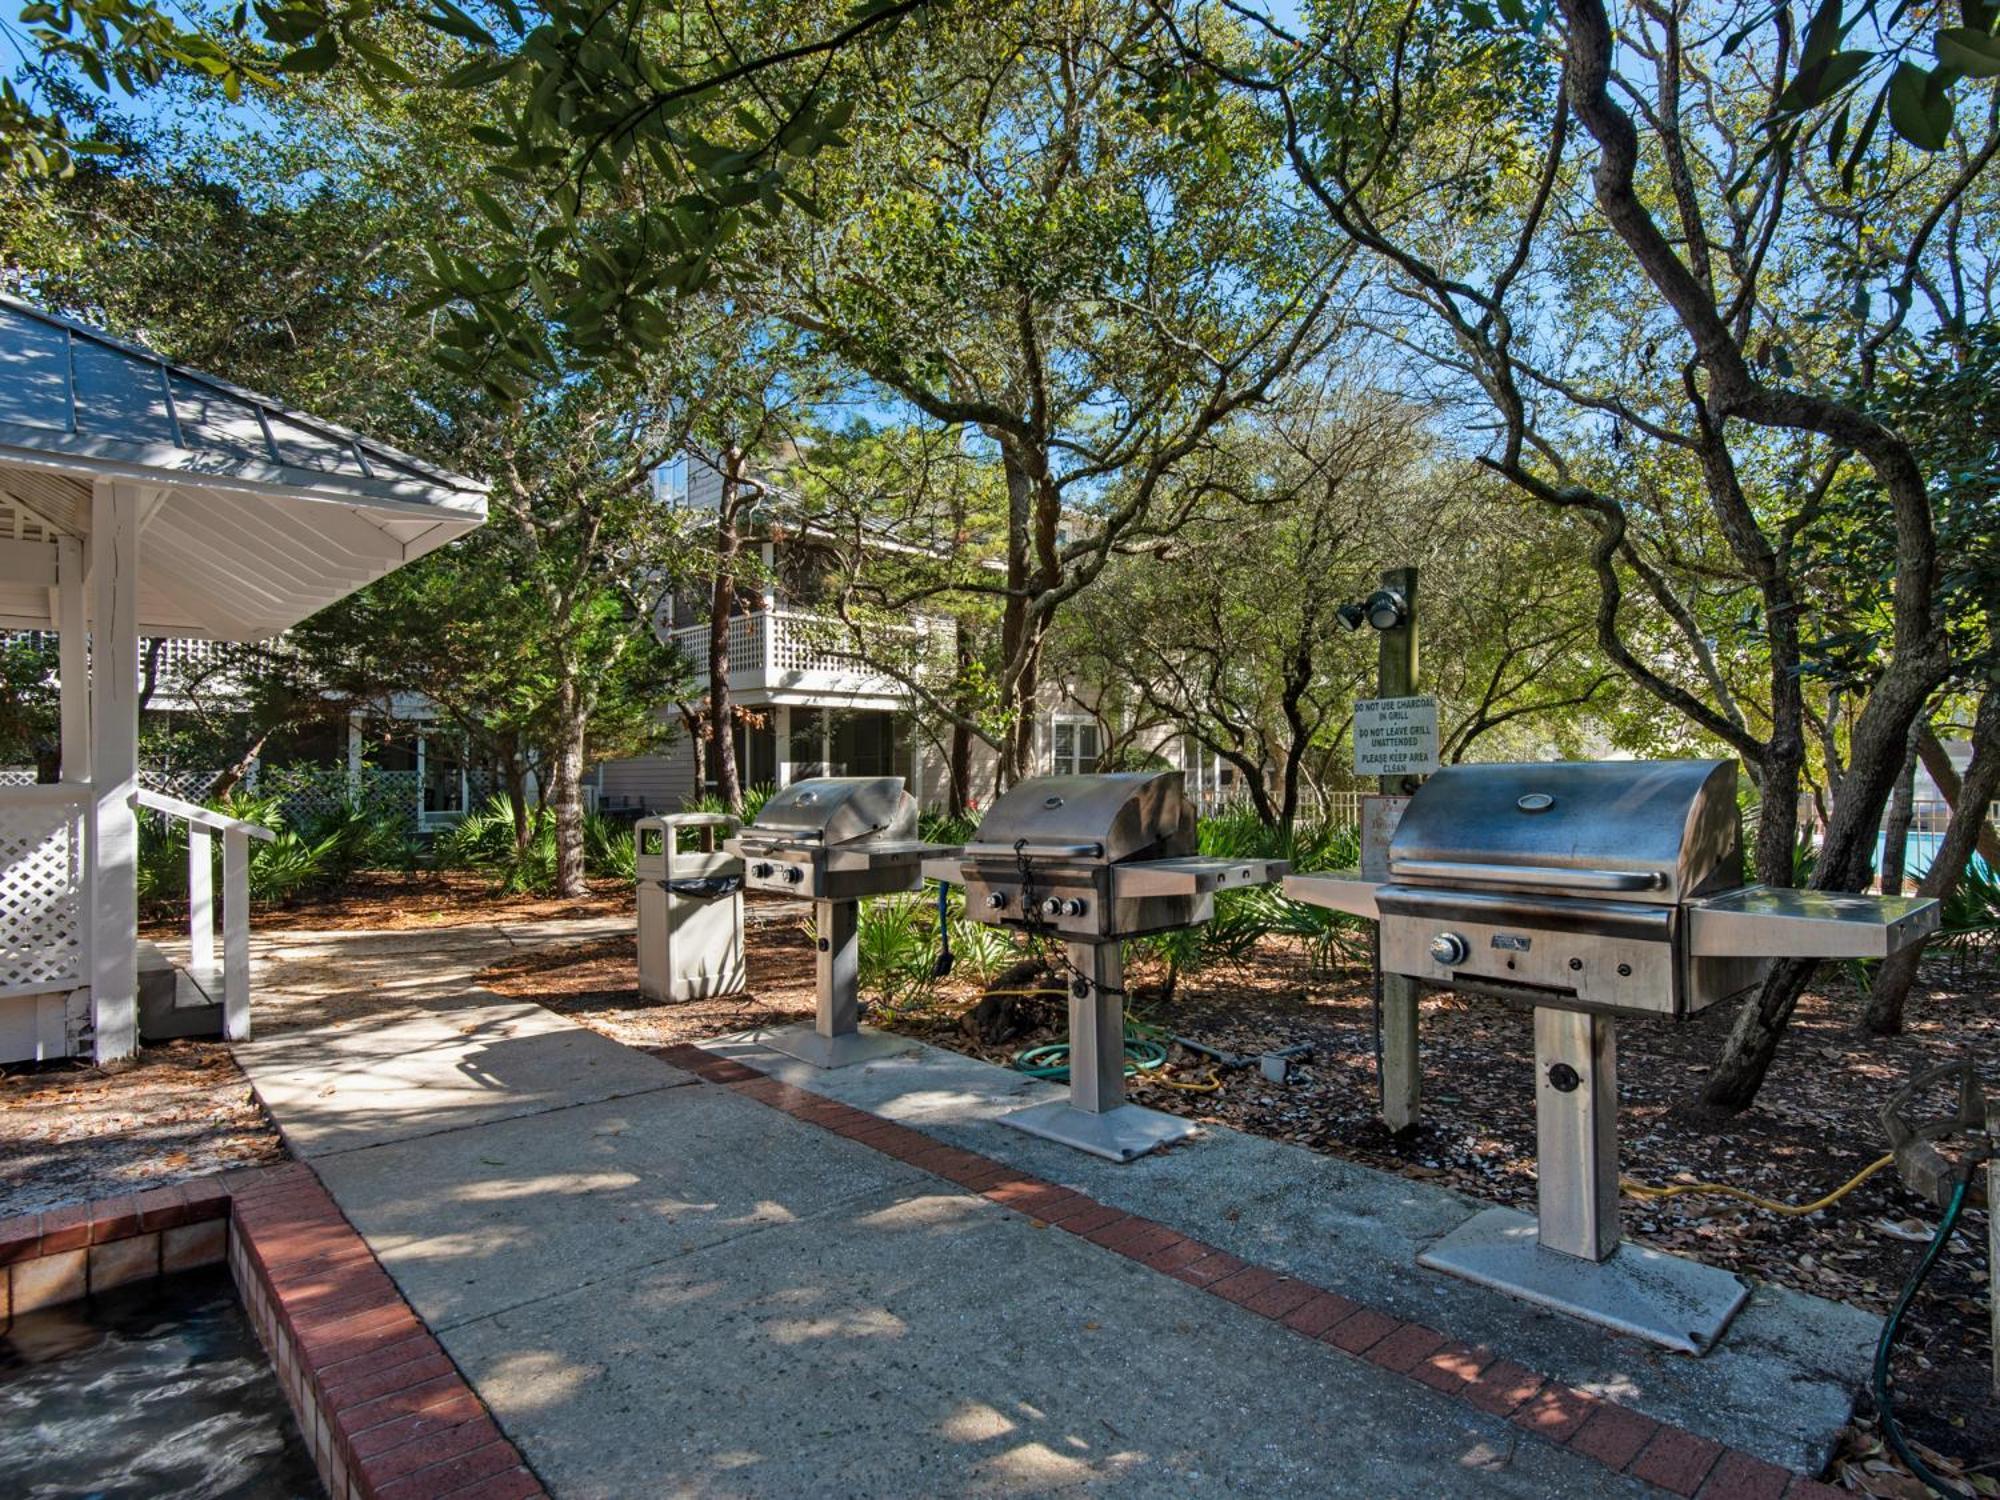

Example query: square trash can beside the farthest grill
[632,812,744,1002]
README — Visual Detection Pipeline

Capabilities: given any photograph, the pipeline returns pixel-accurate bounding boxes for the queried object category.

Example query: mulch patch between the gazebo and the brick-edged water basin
[0,1042,286,1218]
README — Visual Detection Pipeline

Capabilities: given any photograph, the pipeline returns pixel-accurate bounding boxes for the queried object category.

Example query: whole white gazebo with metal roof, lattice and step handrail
[0,296,486,1062]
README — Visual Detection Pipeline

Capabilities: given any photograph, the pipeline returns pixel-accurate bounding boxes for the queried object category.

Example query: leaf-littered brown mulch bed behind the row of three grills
[480,920,2000,1500]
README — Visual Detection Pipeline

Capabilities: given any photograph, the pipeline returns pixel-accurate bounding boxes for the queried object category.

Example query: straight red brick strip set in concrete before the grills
[644,1044,1846,1500]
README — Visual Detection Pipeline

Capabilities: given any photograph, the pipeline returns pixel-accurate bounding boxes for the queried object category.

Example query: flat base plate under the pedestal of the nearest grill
[1416,1208,1750,1354]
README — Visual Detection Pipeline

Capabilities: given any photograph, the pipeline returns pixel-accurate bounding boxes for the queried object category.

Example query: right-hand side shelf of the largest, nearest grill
[1686,886,1940,958]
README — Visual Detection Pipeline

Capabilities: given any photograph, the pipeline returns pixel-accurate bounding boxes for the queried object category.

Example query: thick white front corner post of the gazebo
[90,480,140,1064]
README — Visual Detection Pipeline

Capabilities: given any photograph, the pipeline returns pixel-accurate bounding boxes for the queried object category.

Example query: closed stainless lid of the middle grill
[966,770,1196,864]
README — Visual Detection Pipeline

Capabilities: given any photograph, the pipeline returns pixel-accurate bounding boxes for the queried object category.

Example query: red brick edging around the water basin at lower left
[0,1162,546,1500]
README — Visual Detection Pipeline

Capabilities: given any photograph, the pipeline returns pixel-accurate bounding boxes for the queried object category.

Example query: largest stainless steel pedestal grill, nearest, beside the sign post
[1286,760,1938,1352]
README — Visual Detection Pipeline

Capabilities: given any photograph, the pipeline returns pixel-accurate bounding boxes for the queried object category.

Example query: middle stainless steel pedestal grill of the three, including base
[926,772,1286,1162]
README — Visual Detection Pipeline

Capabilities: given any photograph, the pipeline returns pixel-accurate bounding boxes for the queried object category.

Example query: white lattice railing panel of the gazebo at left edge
[0,784,90,996]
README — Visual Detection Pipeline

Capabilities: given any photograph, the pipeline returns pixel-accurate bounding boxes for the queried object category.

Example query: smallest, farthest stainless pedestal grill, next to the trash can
[724,776,956,1068]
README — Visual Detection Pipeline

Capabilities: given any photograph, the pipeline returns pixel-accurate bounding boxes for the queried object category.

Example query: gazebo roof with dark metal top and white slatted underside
[0,296,486,640]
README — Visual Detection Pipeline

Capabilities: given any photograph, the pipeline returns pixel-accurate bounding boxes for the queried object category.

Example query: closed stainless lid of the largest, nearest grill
[1388,760,1742,902]
